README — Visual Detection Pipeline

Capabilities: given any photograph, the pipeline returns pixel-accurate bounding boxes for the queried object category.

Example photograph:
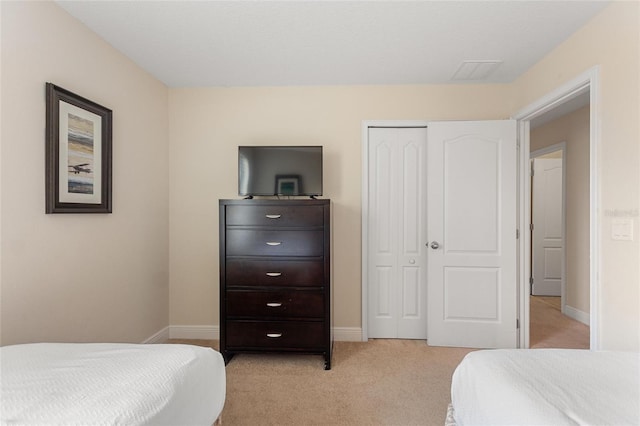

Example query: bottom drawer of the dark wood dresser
[227,320,325,350]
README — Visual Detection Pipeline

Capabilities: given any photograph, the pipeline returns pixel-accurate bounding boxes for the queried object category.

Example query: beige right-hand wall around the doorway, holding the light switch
[514,2,640,350]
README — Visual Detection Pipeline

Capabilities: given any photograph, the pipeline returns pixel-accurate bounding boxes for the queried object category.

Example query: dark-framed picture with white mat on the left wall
[45,83,112,214]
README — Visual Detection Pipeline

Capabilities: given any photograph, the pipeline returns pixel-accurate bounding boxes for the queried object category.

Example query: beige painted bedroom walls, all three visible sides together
[0,2,640,350]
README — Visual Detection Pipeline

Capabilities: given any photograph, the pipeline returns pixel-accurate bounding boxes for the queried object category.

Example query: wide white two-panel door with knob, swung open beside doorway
[427,120,518,348]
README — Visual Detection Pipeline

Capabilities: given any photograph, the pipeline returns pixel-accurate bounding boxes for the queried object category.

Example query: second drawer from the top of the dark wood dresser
[226,229,324,256]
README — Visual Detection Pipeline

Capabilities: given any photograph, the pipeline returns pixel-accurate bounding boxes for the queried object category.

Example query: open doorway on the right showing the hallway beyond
[529,143,589,349]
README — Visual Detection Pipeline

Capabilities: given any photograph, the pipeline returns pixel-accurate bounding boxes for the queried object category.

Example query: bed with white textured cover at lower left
[0,343,226,426]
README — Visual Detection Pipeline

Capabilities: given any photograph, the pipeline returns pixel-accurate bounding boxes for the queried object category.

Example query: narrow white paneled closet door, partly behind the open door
[367,127,427,339]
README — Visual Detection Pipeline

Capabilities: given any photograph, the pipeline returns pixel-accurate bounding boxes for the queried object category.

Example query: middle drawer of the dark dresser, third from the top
[225,259,324,287]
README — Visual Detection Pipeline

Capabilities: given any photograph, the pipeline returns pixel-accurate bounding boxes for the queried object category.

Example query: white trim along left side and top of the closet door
[360,120,429,342]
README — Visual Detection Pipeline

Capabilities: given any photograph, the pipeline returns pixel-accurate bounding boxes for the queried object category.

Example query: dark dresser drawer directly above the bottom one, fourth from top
[227,291,324,318]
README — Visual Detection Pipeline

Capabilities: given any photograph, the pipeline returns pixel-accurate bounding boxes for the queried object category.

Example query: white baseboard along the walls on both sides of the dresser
[143,325,362,343]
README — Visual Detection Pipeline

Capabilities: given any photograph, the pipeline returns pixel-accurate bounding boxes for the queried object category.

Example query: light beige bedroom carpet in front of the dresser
[171,339,471,426]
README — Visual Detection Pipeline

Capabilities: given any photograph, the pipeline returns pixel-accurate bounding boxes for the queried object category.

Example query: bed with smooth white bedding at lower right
[447,349,640,426]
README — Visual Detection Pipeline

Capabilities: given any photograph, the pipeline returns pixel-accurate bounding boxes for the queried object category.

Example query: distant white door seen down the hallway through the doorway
[531,158,564,296]
